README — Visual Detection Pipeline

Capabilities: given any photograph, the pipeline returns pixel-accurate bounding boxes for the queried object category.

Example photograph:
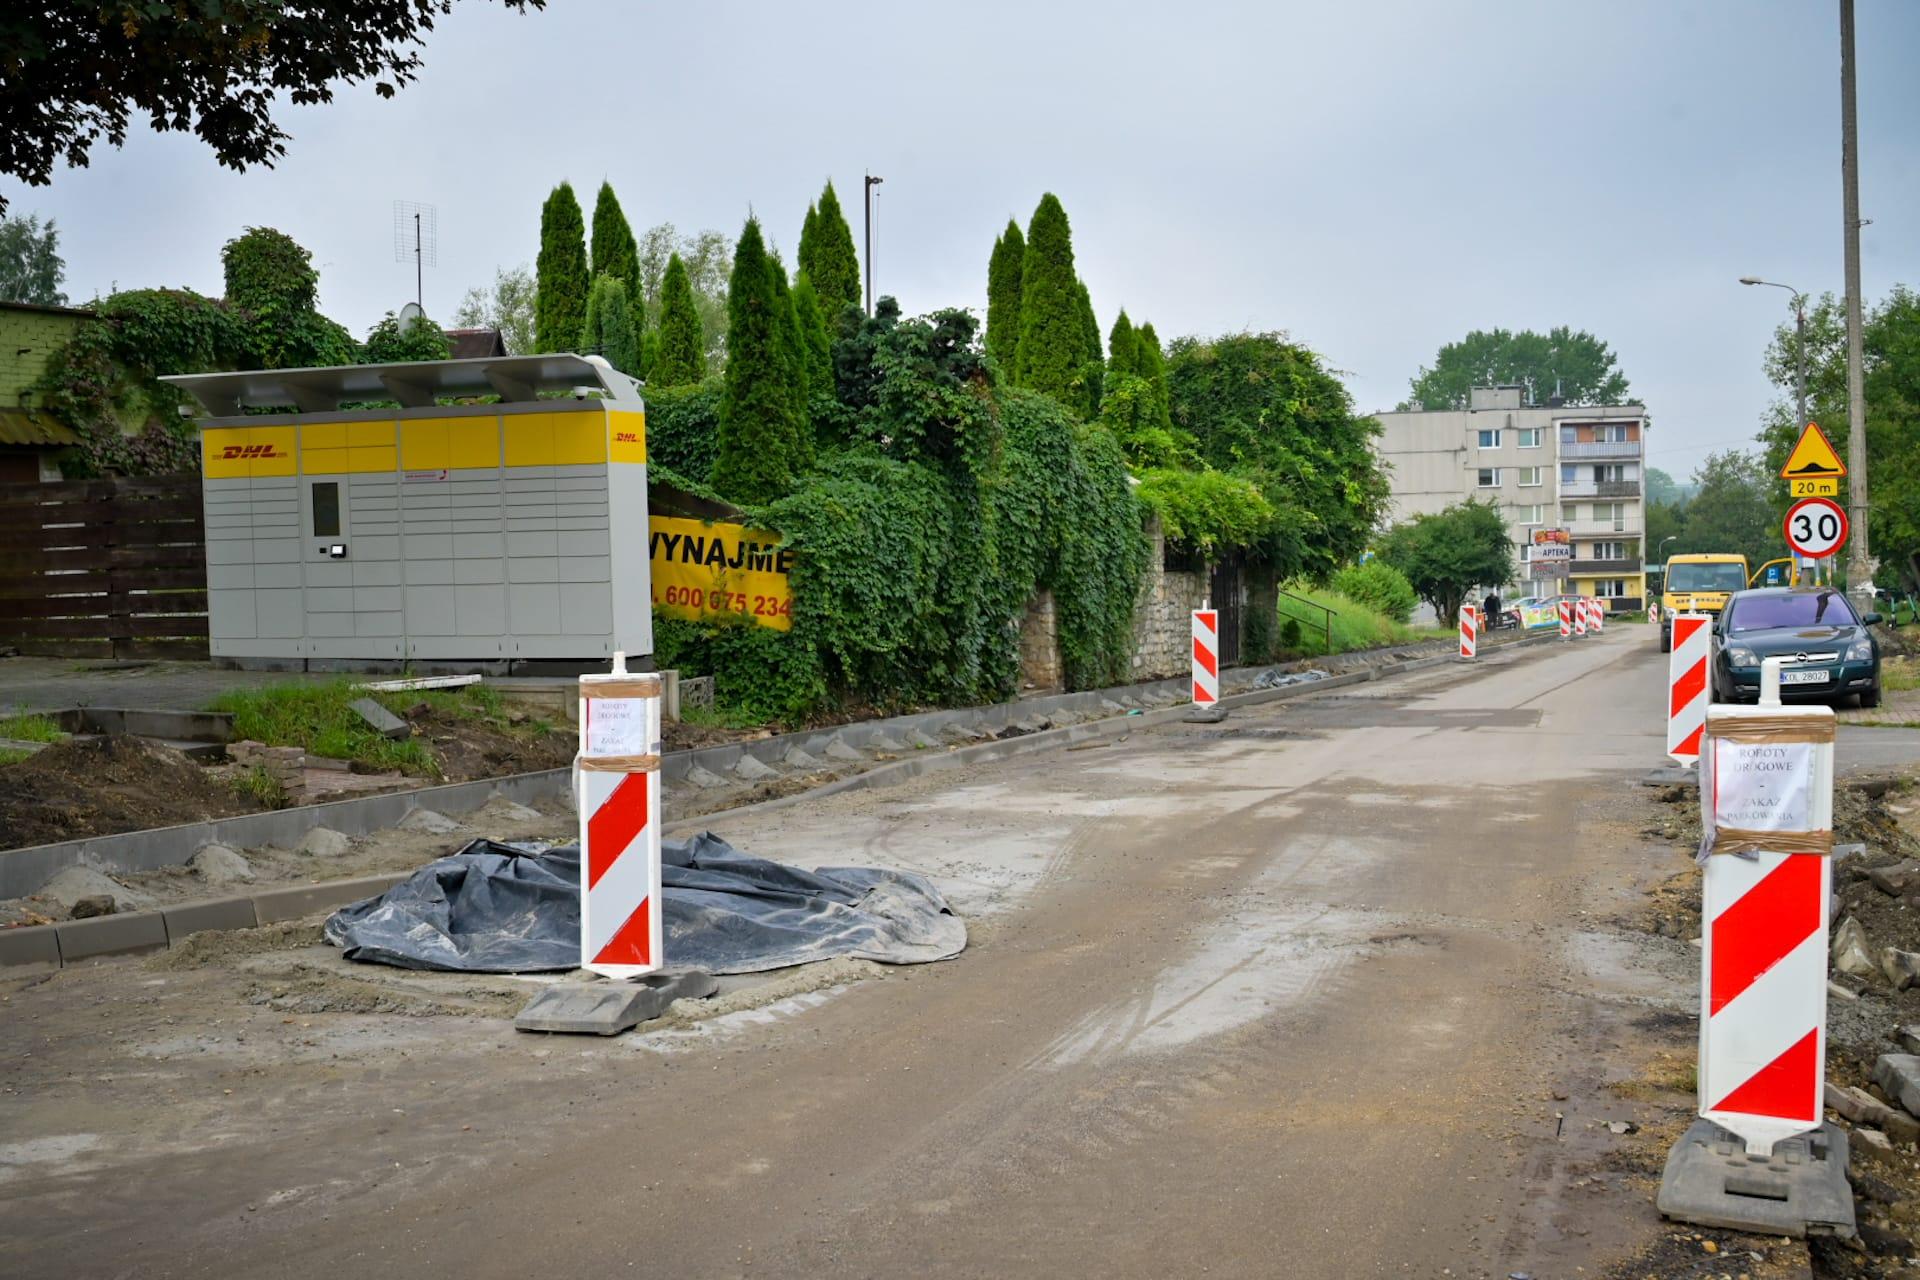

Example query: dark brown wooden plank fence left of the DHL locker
[0,474,207,658]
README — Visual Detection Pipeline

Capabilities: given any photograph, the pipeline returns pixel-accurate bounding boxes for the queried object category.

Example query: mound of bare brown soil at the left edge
[0,737,259,848]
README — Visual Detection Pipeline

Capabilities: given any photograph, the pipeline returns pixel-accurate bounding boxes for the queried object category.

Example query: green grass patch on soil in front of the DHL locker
[207,677,553,777]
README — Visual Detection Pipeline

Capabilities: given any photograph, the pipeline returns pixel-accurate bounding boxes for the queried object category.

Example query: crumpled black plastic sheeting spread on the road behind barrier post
[324,831,966,973]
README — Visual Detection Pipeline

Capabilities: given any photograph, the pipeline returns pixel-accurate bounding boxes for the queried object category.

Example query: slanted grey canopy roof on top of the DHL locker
[161,355,639,418]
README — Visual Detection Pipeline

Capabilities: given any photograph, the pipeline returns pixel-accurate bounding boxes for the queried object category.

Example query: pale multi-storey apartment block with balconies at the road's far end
[1375,386,1649,610]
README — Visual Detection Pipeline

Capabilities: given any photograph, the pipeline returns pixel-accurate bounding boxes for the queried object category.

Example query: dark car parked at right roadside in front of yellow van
[1713,587,1880,706]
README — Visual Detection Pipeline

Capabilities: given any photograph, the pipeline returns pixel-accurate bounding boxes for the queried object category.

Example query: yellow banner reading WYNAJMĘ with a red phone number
[647,516,793,631]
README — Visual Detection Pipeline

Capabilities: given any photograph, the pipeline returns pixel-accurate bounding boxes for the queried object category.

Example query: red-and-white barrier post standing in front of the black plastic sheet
[574,652,666,979]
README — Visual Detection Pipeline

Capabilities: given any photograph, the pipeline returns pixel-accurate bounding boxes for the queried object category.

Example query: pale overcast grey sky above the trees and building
[4,0,1920,476]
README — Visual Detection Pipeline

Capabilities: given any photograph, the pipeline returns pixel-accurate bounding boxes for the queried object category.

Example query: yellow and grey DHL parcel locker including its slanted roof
[167,355,653,670]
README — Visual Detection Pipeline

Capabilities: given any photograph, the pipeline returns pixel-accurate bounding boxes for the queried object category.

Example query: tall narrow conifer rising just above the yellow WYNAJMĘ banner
[714,217,806,503]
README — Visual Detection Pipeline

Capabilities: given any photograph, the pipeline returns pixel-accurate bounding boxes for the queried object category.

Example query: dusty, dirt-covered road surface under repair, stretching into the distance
[0,628,1891,1280]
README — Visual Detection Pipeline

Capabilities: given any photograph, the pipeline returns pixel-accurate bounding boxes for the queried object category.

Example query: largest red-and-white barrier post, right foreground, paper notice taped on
[1704,667,1834,1157]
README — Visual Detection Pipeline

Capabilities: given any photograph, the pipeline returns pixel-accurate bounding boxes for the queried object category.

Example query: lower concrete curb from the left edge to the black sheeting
[0,871,411,977]
